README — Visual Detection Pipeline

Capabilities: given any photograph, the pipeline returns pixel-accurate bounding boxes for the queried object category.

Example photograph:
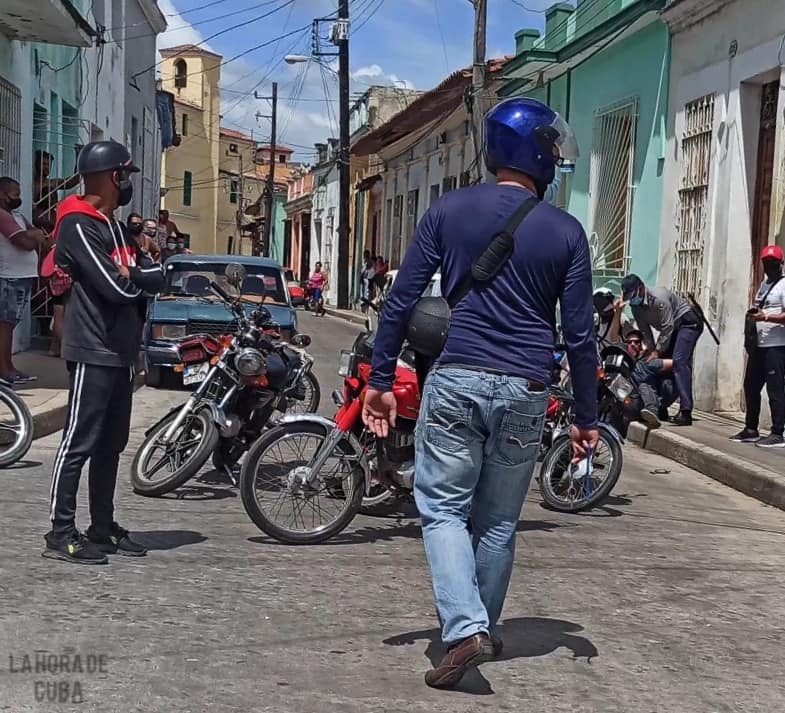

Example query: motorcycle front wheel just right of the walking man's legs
[540,429,623,513]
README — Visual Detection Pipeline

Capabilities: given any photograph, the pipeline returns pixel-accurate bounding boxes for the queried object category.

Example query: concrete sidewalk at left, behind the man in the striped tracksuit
[14,351,142,438]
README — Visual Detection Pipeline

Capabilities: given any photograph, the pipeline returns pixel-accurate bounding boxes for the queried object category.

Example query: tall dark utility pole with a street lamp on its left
[335,0,349,309]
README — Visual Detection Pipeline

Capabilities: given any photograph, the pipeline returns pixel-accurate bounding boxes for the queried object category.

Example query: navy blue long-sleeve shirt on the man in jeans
[370,184,597,428]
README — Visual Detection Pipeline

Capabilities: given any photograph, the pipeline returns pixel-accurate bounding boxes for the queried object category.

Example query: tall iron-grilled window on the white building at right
[673,94,714,295]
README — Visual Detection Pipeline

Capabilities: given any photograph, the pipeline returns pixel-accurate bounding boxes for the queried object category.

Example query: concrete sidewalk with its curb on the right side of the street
[629,413,785,509]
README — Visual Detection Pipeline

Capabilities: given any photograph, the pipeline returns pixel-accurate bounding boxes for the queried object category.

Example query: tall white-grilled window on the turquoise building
[589,101,638,274]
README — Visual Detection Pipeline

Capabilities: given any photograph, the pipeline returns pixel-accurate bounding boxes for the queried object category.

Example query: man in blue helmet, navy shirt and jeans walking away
[363,98,598,688]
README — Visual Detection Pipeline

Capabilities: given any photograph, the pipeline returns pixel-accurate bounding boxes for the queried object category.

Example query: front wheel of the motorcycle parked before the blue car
[131,409,219,497]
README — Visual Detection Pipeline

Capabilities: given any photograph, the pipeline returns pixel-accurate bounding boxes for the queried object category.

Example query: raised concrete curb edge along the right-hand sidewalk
[628,423,785,510]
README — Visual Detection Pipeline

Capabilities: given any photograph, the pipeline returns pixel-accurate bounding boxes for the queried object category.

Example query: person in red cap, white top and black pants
[731,245,785,448]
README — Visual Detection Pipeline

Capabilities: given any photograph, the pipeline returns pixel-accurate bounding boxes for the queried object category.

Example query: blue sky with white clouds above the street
[159,0,554,160]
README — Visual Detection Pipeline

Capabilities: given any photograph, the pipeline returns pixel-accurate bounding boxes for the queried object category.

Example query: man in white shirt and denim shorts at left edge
[0,177,49,383]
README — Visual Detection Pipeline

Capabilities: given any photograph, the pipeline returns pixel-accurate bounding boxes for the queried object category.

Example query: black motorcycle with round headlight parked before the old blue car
[131,265,319,496]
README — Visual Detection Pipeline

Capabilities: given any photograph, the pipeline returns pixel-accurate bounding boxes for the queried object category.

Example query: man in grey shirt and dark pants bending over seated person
[621,275,703,426]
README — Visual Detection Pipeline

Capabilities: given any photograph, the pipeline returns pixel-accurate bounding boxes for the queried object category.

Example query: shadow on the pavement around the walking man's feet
[382,617,600,695]
